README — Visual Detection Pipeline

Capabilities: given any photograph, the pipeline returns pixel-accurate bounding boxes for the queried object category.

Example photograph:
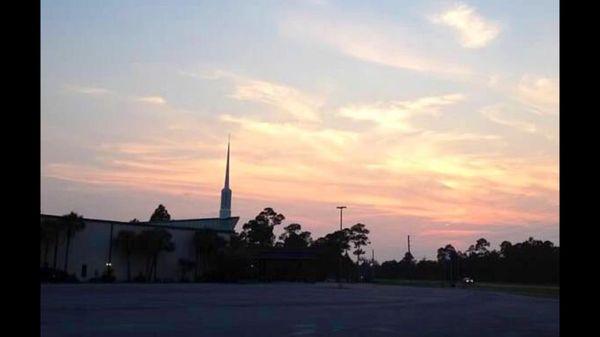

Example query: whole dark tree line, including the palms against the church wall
[40,205,559,283]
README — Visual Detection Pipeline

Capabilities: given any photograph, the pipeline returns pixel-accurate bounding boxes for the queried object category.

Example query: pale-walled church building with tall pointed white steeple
[40,142,239,281]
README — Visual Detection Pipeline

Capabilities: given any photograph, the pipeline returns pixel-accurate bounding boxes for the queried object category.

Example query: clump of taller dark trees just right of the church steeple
[205,207,370,282]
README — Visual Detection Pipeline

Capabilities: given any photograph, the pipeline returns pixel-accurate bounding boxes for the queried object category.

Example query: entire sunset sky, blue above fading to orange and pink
[40,0,559,261]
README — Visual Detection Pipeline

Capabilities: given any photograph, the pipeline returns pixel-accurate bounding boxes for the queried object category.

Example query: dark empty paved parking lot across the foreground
[40,283,559,337]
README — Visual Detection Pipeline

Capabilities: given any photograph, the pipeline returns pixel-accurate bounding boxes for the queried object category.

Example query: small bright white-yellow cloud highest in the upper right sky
[432,4,500,49]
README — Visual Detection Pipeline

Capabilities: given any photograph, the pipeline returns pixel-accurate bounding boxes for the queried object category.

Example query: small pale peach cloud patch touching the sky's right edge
[516,74,559,115]
